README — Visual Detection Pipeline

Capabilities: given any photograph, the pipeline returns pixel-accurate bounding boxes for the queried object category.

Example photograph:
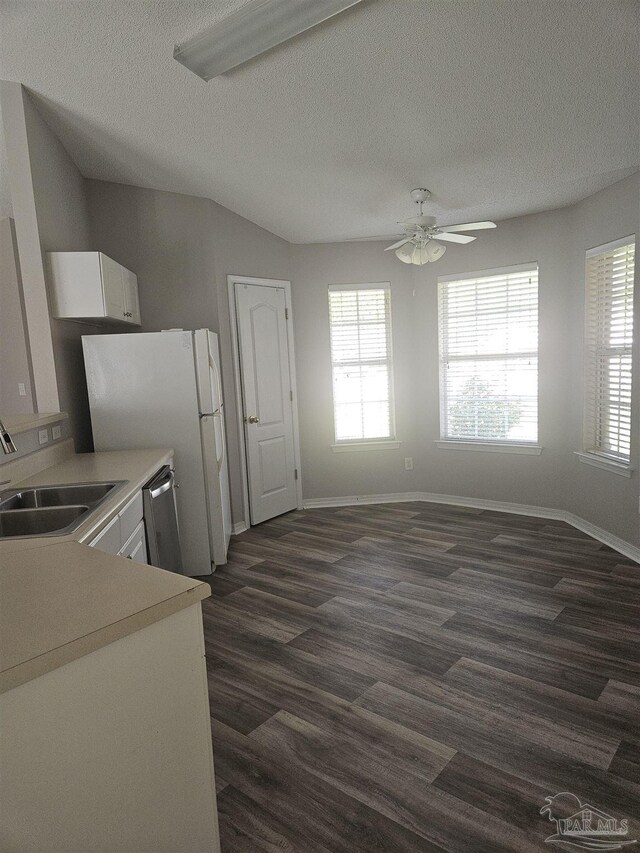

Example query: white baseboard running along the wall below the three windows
[303,492,640,563]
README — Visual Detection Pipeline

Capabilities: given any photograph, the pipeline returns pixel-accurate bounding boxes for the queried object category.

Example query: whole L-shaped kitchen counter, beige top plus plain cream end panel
[0,442,220,853]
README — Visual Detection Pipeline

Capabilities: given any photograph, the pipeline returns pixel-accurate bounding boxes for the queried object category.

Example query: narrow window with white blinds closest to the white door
[329,283,394,442]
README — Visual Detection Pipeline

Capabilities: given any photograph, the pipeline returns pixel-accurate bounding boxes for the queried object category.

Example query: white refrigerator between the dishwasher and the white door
[82,329,231,577]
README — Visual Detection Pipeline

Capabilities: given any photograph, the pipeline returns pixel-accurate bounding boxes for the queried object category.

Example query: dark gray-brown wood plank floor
[198,503,640,853]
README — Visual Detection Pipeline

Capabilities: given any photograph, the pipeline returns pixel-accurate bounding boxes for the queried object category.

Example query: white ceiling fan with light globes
[384,187,496,266]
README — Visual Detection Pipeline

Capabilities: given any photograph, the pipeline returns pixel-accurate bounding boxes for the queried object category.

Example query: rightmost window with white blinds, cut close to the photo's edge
[584,236,635,463]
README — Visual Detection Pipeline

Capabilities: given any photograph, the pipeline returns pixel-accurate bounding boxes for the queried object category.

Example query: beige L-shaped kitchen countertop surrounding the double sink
[0,449,211,692]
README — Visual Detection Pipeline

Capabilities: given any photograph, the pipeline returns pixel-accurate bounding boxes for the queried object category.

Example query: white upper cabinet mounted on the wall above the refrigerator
[47,252,140,326]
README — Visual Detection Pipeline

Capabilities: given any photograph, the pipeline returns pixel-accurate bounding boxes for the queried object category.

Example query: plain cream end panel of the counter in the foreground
[0,603,220,853]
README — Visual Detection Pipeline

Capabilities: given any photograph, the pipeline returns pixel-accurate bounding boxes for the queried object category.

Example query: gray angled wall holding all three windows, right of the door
[291,175,640,544]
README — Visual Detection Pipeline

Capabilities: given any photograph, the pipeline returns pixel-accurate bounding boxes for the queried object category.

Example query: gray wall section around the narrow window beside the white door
[291,243,424,498]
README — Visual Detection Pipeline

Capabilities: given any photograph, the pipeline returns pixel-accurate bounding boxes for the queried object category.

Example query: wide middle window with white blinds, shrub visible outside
[438,264,538,444]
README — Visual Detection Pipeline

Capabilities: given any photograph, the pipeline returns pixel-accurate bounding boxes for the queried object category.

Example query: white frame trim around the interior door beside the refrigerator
[227,274,302,529]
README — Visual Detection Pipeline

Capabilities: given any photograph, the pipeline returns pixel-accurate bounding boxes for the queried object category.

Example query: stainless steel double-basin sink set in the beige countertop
[0,480,125,539]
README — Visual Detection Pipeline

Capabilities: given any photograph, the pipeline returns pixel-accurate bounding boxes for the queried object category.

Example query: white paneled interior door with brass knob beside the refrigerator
[235,283,297,524]
